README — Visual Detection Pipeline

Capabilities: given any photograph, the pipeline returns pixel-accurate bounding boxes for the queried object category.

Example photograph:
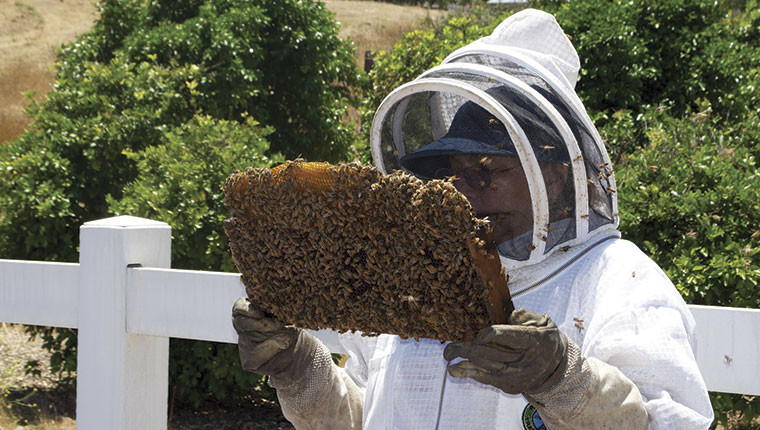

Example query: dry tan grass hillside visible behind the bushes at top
[0,0,446,144]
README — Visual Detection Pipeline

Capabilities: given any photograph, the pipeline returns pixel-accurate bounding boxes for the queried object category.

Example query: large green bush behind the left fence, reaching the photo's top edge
[0,0,362,402]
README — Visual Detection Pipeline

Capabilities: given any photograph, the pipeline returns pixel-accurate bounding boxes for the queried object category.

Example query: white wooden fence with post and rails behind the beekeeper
[0,216,760,430]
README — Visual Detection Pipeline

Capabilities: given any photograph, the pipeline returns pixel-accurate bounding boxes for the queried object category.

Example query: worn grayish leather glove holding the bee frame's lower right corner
[443,309,568,394]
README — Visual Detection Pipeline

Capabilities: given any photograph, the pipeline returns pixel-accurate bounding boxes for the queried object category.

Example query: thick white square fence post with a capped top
[76,216,171,430]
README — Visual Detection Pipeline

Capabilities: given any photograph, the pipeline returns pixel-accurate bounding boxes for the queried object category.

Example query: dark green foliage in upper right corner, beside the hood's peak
[539,0,760,120]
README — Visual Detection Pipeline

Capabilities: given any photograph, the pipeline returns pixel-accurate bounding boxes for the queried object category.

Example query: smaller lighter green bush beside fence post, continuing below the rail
[107,116,284,404]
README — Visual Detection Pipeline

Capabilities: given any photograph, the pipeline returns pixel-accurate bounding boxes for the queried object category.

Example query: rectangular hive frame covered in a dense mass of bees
[224,160,511,341]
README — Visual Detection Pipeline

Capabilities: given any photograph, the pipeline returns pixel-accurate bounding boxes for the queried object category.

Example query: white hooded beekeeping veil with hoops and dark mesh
[371,9,618,269]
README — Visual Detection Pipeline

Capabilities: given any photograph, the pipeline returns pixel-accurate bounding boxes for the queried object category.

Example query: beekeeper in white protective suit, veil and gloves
[233,9,713,430]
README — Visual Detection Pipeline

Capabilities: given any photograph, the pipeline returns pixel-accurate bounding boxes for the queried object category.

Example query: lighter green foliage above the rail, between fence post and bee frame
[107,116,284,272]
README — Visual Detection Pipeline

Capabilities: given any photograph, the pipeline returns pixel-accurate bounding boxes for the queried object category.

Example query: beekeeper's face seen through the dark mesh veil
[450,155,533,243]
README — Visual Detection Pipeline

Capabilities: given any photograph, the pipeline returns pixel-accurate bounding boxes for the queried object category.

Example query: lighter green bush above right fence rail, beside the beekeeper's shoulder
[616,107,760,308]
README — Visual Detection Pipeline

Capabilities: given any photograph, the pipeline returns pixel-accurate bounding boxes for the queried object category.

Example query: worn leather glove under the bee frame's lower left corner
[232,298,312,385]
